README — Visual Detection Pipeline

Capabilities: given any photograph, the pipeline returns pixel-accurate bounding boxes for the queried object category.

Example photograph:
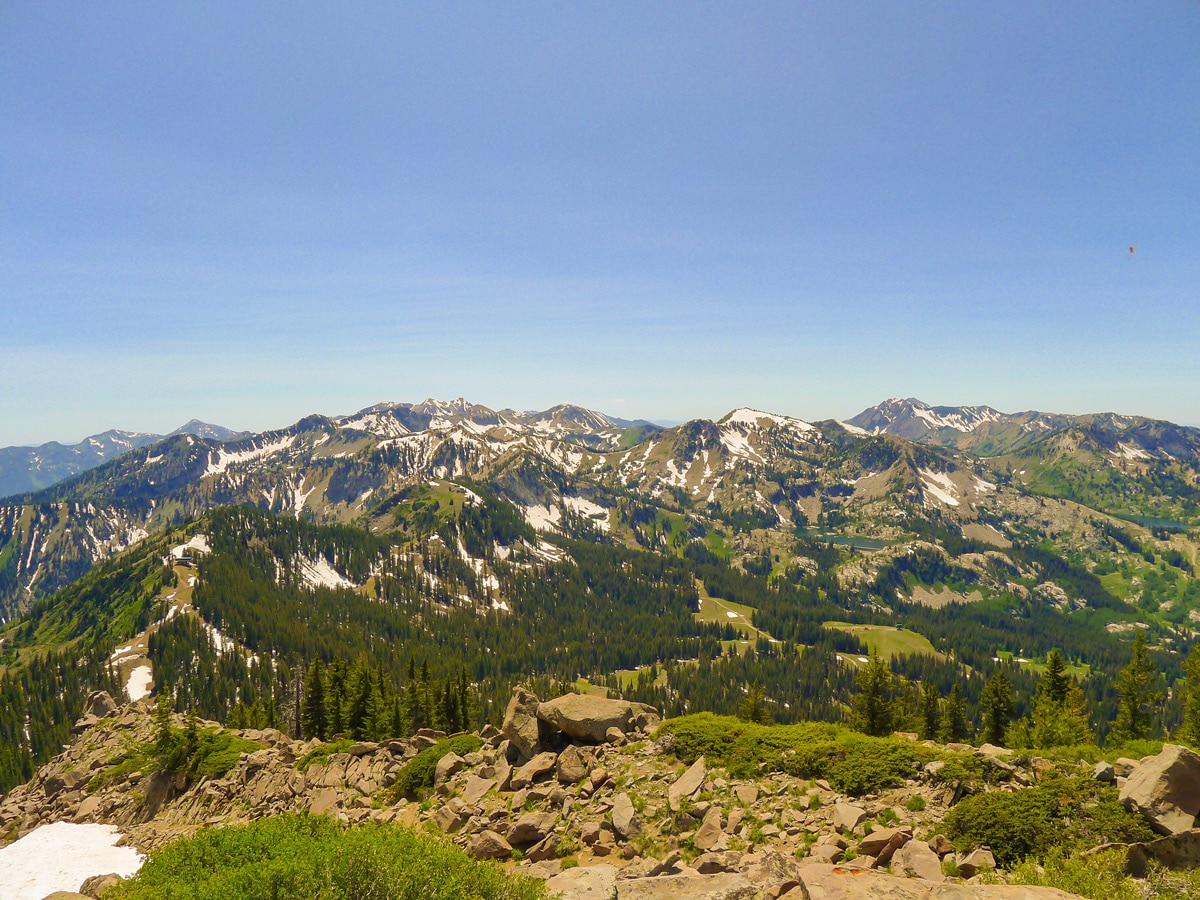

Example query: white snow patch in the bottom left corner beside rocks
[0,822,145,900]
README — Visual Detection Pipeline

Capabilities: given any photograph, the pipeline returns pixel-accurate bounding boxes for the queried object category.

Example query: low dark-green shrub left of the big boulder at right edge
[942,775,1154,868]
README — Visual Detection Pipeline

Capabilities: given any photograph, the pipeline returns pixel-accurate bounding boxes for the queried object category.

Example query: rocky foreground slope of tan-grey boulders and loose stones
[0,690,1200,900]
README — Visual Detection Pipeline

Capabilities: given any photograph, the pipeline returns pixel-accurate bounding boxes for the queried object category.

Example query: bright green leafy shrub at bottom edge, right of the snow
[106,816,545,900]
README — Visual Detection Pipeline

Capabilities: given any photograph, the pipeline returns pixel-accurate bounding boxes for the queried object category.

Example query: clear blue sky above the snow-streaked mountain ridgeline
[0,0,1200,444]
